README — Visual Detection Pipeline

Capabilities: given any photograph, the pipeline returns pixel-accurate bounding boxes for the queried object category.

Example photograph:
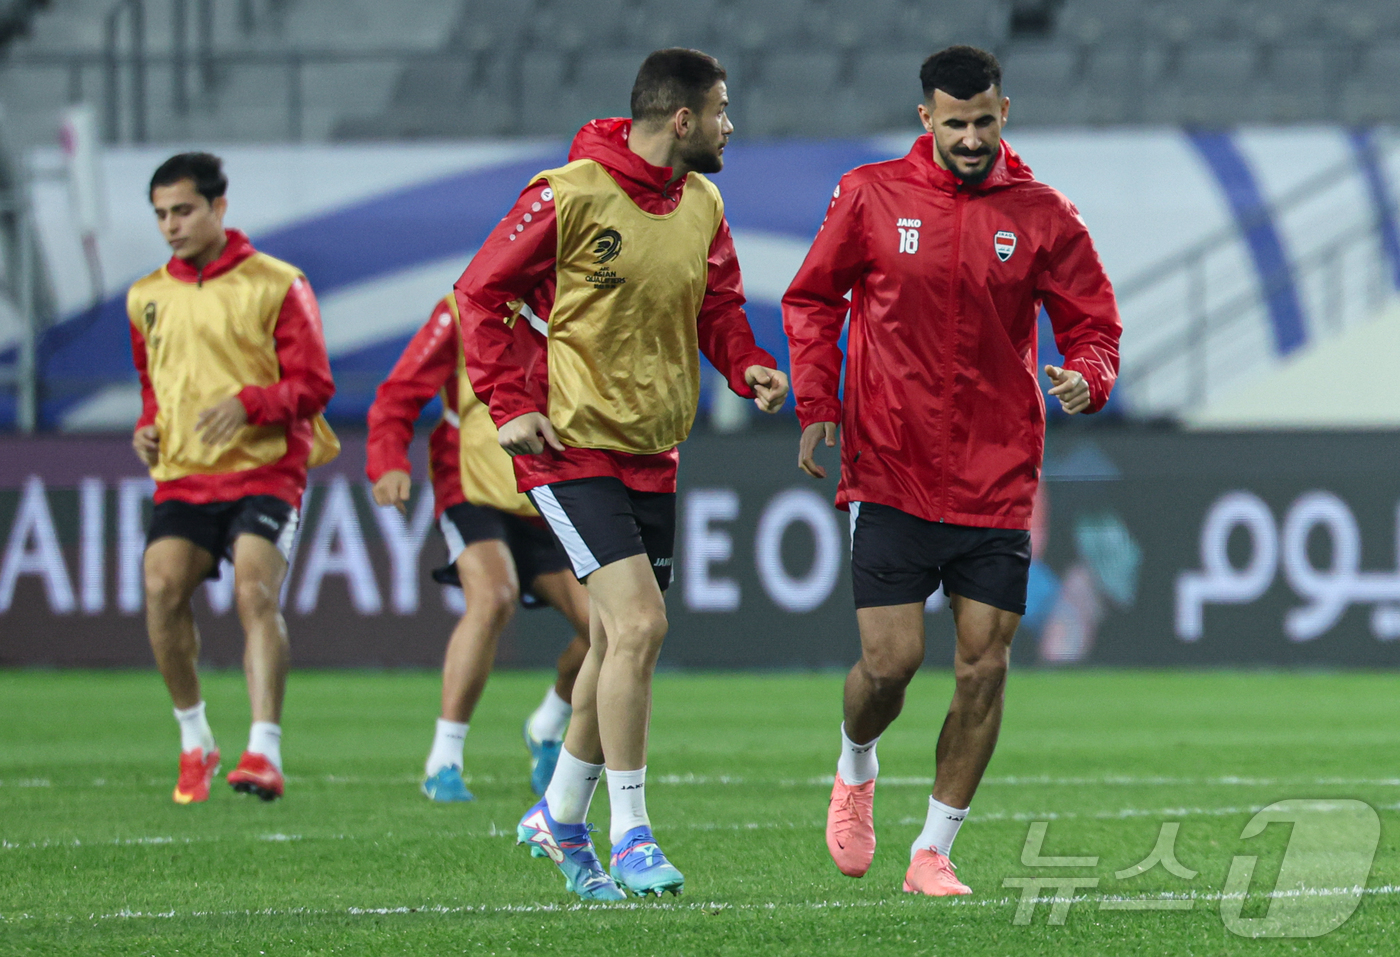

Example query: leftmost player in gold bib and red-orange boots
[126,153,340,804]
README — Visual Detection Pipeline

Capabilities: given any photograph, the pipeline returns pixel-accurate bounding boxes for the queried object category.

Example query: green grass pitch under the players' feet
[0,672,1400,957]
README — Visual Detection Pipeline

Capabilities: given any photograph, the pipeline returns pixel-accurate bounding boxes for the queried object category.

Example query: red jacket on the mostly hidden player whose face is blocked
[364,298,466,518]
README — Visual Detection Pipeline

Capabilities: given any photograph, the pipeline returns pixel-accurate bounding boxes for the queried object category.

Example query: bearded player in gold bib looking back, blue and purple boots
[456,49,788,900]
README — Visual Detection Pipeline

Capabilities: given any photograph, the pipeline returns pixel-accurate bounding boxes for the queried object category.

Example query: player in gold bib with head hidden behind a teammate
[365,295,588,802]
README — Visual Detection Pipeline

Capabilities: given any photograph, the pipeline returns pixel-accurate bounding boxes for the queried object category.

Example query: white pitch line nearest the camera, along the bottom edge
[8,884,1400,923]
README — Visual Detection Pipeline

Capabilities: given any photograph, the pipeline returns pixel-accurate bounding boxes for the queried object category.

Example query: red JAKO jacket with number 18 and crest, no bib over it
[783,134,1123,529]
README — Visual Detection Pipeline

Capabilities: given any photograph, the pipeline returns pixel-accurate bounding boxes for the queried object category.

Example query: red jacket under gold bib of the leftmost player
[126,229,336,508]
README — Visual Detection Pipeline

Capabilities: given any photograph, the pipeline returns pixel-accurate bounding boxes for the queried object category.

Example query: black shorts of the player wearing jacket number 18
[851,502,1030,614]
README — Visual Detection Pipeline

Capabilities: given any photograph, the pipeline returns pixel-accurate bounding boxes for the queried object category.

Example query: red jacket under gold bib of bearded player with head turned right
[454,119,776,492]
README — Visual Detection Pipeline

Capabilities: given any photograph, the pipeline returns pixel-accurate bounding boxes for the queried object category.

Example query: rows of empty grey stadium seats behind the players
[0,0,1400,148]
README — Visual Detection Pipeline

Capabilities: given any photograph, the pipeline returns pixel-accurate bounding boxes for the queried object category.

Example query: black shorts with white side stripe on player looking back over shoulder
[526,477,676,592]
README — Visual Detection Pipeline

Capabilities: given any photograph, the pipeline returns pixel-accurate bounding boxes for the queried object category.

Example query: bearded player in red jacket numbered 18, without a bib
[783,46,1121,895]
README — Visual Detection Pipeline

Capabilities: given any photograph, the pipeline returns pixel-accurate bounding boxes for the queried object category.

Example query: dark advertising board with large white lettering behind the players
[8,427,1400,669]
